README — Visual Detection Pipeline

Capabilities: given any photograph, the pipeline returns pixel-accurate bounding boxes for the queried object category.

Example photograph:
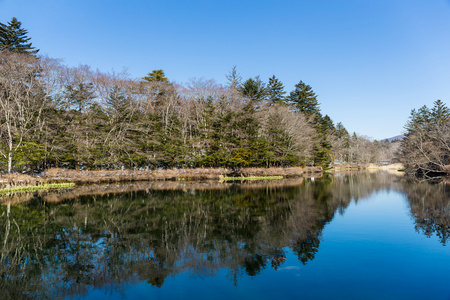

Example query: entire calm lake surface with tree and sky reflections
[0,173,450,300]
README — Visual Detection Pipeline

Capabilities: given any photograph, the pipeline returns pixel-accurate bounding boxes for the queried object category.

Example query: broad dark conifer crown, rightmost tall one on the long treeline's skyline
[289,81,320,120]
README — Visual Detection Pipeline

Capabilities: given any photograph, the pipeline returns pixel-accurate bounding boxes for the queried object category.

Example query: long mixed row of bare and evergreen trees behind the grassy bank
[0,18,400,172]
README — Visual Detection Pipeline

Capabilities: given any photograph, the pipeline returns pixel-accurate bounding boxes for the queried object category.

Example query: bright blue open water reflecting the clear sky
[81,191,450,300]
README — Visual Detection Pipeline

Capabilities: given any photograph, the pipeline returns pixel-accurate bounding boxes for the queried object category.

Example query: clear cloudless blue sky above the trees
[0,0,450,139]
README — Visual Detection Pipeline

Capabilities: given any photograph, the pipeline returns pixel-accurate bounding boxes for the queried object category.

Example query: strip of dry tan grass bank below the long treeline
[0,164,408,193]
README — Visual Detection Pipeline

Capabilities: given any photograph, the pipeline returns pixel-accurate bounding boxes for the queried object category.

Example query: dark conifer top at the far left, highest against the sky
[0,17,39,54]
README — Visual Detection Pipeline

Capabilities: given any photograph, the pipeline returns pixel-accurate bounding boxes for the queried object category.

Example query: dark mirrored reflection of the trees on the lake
[0,173,450,299]
